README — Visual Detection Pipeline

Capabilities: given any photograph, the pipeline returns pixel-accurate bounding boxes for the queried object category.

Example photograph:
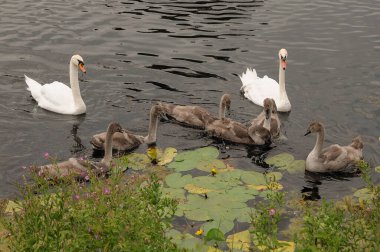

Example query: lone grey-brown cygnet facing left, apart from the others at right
[305,122,363,172]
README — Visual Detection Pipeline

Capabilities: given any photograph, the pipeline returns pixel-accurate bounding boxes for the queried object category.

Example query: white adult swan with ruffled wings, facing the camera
[239,49,291,112]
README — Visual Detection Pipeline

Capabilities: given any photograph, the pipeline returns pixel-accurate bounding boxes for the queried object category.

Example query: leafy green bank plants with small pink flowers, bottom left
[0,170,176,251]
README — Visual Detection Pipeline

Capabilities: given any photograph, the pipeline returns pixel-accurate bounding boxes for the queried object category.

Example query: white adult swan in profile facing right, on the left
[25,55,86,115]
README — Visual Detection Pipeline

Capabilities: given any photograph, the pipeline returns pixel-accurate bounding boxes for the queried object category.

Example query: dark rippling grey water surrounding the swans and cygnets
[0,0,380,198]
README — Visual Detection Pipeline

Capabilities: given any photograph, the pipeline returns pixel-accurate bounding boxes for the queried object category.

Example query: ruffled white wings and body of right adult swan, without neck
[240,69,280,106]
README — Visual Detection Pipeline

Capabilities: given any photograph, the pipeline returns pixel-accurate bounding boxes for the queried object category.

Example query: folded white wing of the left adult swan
[38,81,74,113]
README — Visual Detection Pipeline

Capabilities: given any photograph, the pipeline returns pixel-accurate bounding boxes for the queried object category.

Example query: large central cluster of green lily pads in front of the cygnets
[164,147,282,233]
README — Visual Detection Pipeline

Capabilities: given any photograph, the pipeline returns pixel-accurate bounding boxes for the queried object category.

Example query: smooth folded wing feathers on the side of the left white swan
[41,81,74,107]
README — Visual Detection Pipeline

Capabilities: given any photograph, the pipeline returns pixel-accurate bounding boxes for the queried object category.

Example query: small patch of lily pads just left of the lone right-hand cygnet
[265,153,305,174]
